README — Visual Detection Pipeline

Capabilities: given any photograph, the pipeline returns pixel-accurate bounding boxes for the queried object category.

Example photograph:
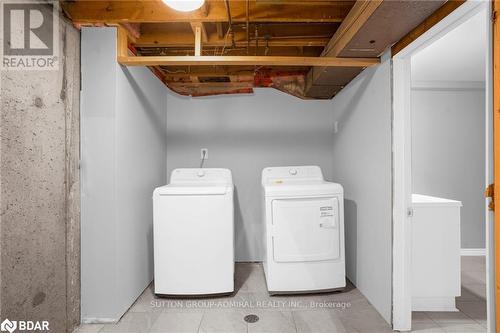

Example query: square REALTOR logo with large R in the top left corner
[1,1,59,70]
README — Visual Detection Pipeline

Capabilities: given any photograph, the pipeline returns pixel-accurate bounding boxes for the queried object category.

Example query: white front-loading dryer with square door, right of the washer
[262,166,346,294]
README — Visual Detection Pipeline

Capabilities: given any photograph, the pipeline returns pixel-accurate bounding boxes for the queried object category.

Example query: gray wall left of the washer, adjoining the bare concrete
[81,28,166,322]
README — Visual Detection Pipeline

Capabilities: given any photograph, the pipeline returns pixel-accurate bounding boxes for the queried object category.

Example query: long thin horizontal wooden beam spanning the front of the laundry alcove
[118,52,380,67]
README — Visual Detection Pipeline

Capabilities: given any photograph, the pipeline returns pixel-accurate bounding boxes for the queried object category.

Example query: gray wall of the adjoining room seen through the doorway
[412,87,486,248]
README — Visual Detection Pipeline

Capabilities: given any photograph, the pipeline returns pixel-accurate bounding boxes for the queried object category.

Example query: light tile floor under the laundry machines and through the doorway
[74,257,486,333]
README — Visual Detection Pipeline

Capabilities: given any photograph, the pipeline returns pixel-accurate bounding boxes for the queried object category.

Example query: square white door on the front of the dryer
[272,198,340,262]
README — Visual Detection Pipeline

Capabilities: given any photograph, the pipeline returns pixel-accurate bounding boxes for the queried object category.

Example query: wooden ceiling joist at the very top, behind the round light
[61,0,352,24]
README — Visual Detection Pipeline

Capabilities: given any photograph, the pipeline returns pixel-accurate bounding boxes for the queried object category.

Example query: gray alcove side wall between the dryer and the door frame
[331,54,392,322]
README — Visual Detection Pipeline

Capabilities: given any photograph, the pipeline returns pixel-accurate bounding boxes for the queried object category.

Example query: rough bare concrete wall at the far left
[0,7,80,333]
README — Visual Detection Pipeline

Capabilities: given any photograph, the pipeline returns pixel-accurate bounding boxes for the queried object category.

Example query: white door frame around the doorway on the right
[392,0,495,332]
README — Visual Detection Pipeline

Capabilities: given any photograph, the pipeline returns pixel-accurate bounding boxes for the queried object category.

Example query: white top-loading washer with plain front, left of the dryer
[153,169,234,295]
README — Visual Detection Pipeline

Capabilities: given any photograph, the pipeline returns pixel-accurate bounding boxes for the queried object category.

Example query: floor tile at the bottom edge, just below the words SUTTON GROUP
[150,312,203,333]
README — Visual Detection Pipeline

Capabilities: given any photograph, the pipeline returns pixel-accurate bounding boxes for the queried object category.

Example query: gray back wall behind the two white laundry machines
[167,89,336,261]
